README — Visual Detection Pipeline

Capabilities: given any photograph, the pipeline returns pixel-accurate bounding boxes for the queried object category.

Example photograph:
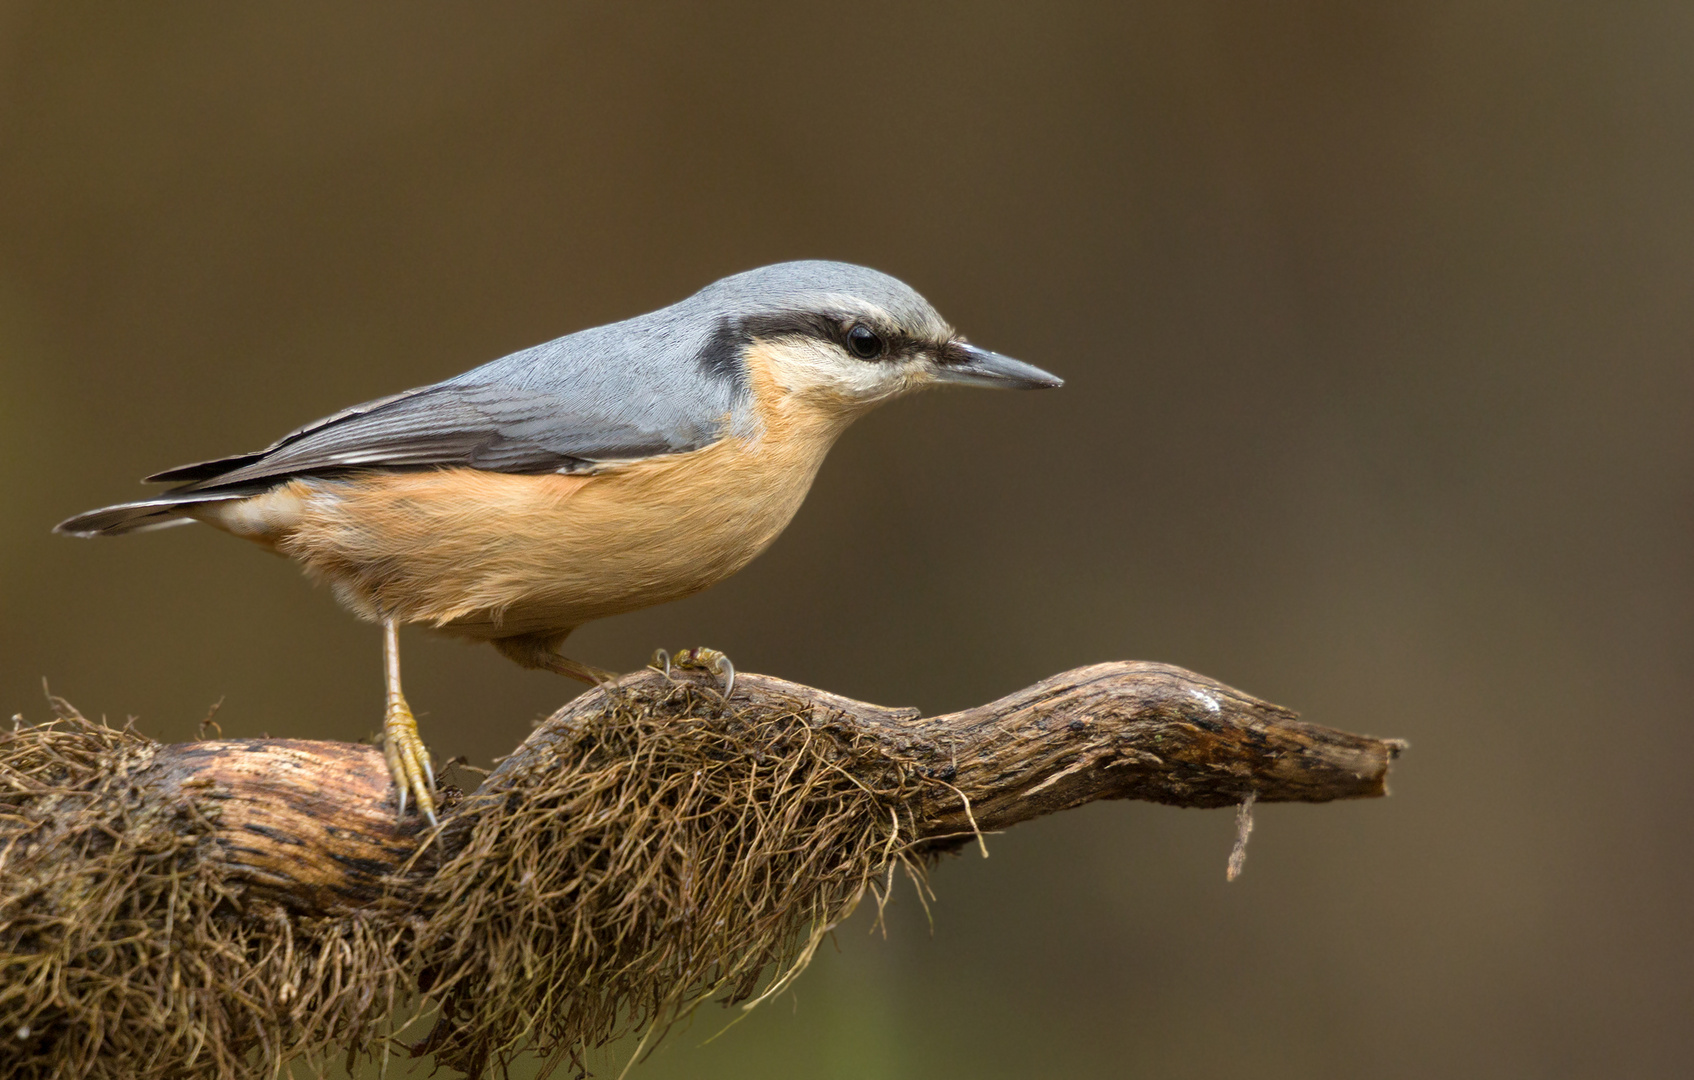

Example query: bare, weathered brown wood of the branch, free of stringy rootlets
[147,662,1404,914]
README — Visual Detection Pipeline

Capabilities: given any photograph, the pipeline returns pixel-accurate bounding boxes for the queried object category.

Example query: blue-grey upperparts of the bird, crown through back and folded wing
[151,262,945,491]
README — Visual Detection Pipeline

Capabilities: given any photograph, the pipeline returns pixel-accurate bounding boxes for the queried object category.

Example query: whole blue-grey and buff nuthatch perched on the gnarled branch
[54,261,1062,826]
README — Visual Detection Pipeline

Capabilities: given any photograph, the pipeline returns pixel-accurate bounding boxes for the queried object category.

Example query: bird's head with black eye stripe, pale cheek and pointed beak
[695,262,1062,418]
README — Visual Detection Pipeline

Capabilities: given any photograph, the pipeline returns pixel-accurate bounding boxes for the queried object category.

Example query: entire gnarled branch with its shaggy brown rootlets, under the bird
[0,664,1404,1077]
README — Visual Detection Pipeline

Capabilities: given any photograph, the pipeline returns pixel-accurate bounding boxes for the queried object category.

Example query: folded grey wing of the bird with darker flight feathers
[147,383,717,491]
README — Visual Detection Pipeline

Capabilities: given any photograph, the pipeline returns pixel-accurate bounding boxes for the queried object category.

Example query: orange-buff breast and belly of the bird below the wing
[195,438,832,640]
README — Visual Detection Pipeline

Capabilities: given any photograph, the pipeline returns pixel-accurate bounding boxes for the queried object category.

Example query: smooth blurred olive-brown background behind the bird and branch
[0,0,1694,1078]
